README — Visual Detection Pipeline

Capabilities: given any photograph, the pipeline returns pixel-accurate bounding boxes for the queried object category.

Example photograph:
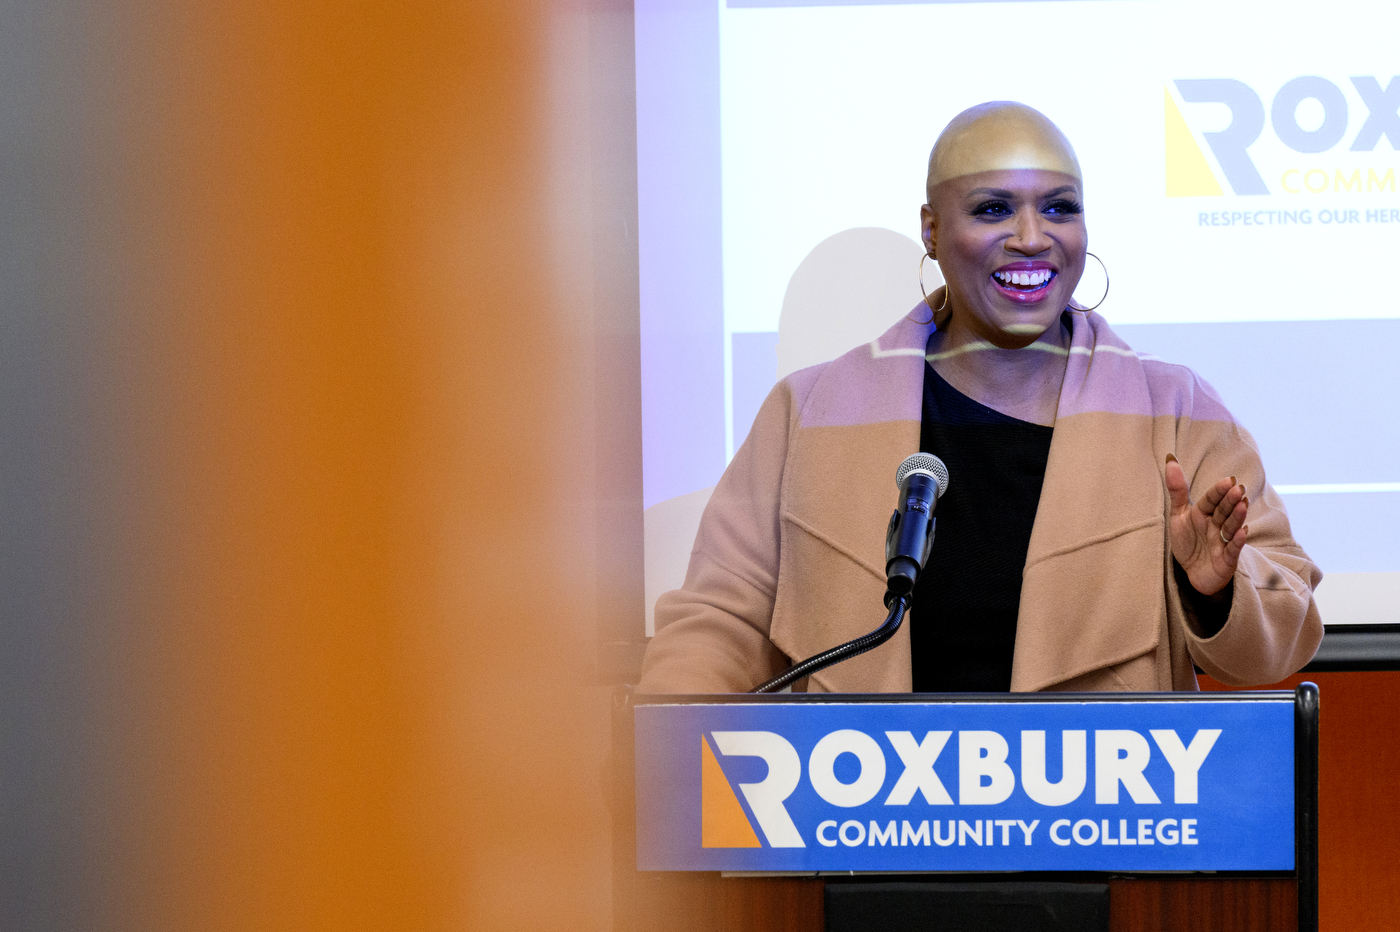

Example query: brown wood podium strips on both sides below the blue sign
[617,873,1298,932]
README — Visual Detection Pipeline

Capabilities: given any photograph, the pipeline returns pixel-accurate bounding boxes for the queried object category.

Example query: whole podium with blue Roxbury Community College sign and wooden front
[613,683,1319,932]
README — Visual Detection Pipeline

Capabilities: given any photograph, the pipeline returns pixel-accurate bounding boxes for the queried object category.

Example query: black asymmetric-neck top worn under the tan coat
[909,364,1054,693]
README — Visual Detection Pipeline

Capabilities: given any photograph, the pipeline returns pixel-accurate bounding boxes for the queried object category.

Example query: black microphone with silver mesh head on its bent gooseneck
[750,453,948,693]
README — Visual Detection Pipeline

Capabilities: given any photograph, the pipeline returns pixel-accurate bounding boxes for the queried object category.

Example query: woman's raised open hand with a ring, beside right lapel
[1166,453,1249,596]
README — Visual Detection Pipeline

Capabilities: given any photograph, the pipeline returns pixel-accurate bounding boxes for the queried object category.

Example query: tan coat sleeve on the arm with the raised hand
[1168,369,1323,686]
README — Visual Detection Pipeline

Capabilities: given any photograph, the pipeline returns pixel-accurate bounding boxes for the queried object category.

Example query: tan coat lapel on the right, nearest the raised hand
[1012,312,1166,691]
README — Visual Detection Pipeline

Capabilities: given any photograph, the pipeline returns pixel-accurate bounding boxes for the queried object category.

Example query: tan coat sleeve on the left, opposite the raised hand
[637,379,799,694]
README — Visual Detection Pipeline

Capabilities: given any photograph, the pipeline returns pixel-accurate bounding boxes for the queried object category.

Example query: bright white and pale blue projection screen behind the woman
[636,0,1400,634]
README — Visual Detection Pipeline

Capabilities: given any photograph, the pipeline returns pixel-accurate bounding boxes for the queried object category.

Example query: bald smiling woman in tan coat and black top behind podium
[640,102,1323,693]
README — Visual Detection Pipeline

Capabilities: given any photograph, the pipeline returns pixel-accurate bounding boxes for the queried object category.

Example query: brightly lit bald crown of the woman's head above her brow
[928,101,1084,200]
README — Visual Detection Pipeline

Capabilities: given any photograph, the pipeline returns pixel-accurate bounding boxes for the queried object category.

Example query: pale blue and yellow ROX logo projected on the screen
[1165,76,1400,197]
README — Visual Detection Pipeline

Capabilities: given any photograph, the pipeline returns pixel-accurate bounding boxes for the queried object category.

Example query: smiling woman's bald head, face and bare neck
[920,104,1088,425]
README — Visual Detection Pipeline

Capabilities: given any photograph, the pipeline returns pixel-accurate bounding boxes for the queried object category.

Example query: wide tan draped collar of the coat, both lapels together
[771,304,1165,691]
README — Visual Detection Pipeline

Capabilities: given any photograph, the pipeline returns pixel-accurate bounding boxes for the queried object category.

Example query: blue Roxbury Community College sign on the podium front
[634,693,1295,872]
